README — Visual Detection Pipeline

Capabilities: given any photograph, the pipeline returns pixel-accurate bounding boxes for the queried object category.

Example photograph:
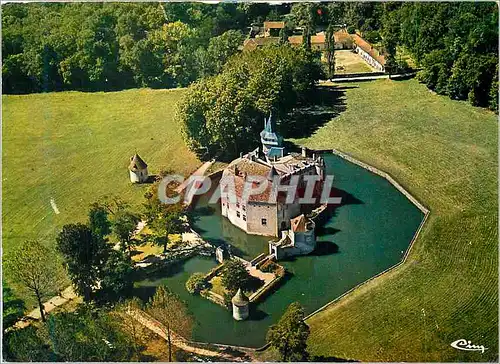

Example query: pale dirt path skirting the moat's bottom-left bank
[128,311,255,362]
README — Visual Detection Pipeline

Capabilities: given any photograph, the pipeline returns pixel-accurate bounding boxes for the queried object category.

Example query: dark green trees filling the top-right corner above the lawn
[396,3,498,110]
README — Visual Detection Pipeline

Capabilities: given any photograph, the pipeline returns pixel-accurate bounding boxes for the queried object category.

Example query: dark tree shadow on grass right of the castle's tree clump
[279,86,352,138]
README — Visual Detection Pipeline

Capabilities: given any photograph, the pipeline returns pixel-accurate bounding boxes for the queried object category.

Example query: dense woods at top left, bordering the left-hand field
[2,3,262,93]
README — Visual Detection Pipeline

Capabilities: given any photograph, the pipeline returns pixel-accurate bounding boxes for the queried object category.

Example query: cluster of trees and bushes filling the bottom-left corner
[3,188,195,361]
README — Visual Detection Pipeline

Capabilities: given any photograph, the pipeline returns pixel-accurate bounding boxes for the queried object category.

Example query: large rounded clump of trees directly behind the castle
[176,45,322,159]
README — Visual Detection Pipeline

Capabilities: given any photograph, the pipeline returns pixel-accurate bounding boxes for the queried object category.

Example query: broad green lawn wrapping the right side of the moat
[296,80,498,361]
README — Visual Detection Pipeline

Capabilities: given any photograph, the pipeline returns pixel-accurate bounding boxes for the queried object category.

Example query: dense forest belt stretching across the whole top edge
[2,2,498,110]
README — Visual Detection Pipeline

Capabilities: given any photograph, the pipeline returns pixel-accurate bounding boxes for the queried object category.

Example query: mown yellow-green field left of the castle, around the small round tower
[2,89,200,292]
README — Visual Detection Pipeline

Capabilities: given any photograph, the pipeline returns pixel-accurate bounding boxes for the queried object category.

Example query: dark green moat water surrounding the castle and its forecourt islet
[135,155,423,346]
